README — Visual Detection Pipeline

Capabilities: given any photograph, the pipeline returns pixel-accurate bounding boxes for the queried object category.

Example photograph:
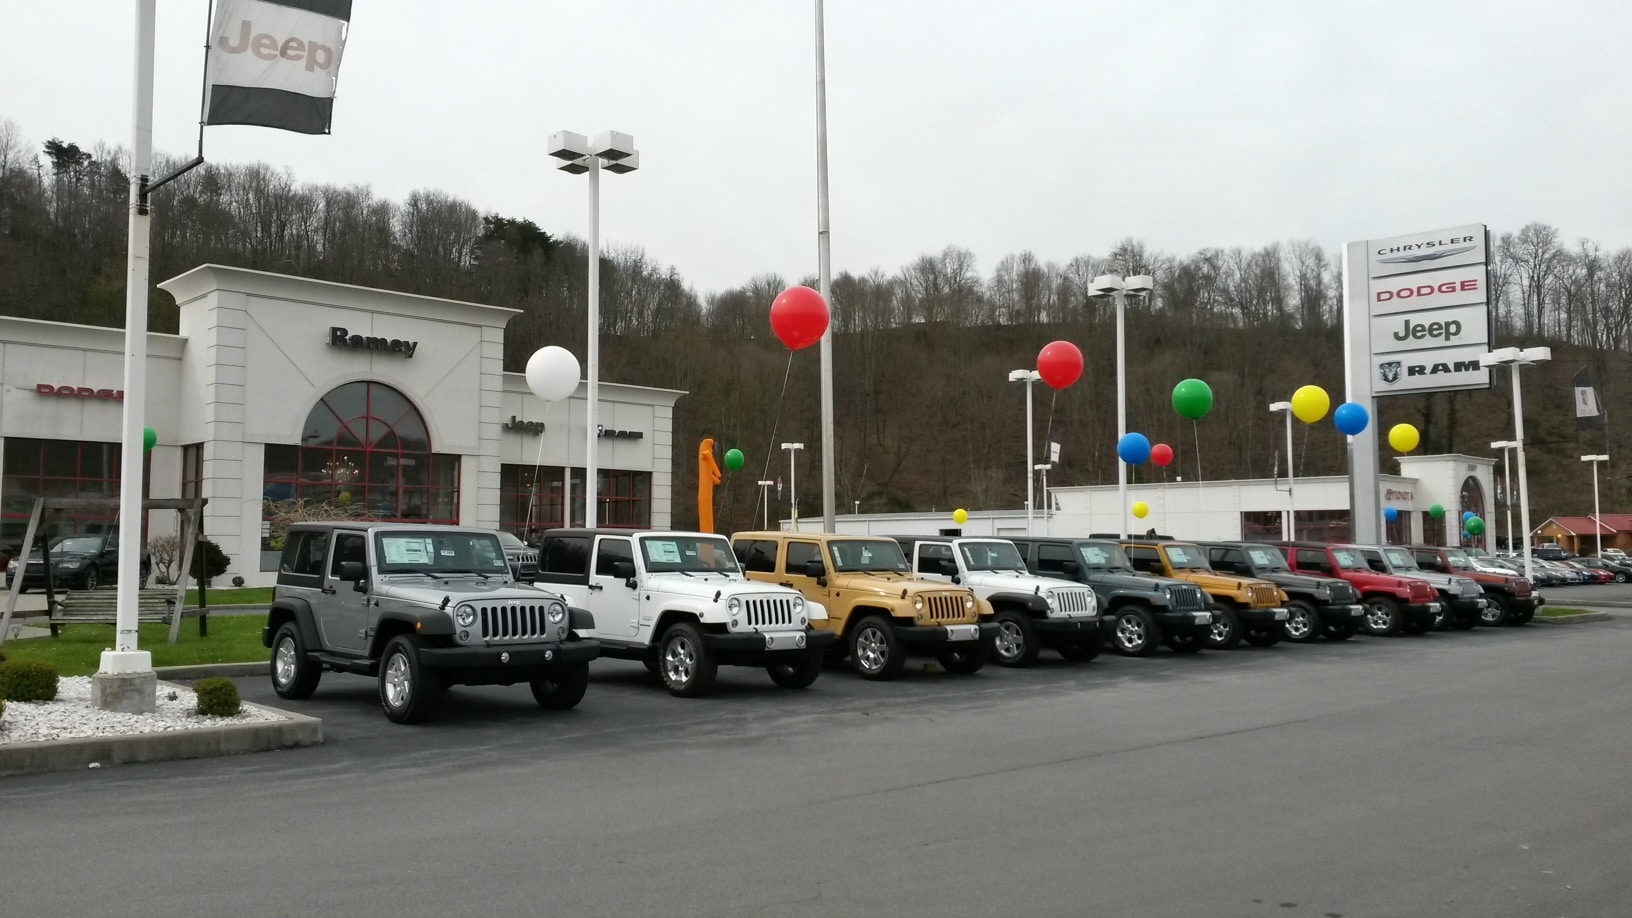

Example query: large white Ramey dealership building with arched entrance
[0,265,682,585]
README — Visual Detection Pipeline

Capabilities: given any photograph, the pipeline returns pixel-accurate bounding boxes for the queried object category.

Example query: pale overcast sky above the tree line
[0,0,1632,294]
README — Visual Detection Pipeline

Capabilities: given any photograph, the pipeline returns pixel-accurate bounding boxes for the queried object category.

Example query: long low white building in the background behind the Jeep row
[822,454,1497,549]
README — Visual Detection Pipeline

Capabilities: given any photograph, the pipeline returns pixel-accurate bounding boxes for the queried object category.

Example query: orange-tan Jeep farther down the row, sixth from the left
[1123,539,1288,650]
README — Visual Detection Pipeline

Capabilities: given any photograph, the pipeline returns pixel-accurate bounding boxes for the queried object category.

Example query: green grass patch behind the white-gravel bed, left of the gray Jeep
[0,614,271,676]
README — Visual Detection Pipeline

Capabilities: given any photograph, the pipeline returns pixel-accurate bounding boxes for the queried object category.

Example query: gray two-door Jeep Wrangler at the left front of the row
[261,521,601,724]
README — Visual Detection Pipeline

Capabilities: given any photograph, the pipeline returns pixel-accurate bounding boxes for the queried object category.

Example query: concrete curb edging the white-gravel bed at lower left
[0,679,323,776]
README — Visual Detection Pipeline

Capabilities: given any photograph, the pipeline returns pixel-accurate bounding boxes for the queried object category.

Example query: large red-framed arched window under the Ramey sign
[263,381,459,523]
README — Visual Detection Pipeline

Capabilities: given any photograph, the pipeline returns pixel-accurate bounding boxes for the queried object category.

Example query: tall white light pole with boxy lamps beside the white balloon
[547,131,640,529]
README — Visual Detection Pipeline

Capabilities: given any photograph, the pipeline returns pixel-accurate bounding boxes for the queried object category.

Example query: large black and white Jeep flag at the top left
[204,0,351,134]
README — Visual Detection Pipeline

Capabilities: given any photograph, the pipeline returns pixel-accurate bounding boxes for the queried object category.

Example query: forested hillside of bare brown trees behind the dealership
[0,119,1632,528]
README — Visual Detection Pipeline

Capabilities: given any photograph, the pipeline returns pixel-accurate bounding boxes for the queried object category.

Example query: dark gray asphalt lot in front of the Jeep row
[0,617,1632,918]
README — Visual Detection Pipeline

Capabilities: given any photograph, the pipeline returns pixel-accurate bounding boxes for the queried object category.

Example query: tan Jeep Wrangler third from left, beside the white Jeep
[731,533,997,680]
